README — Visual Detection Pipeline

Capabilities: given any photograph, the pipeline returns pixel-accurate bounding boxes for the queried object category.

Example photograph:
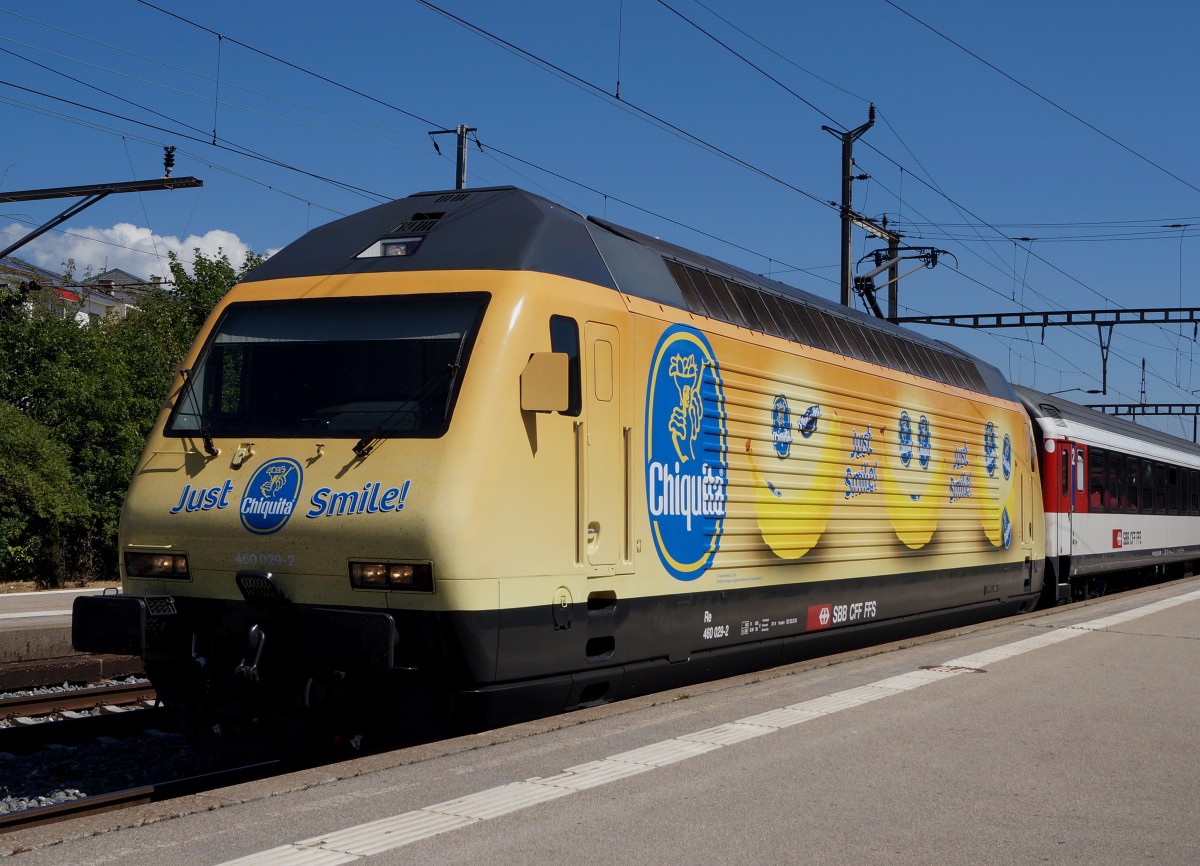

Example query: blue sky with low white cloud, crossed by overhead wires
[0,0,1200,438]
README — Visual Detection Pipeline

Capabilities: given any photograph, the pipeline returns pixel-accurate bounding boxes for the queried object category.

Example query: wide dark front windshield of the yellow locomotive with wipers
[167,294,487,440]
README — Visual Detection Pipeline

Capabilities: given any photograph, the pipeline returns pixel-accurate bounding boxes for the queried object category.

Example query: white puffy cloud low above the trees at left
[0,223,264,278]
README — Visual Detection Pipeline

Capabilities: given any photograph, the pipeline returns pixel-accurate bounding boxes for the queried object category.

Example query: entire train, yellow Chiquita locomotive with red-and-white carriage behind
[73,187,1200,747]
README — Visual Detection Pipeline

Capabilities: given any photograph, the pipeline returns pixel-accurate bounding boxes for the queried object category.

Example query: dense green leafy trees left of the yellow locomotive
[0,242,262,585]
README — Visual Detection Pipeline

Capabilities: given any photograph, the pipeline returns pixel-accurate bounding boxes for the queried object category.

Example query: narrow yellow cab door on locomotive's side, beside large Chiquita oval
[583,321,629,575]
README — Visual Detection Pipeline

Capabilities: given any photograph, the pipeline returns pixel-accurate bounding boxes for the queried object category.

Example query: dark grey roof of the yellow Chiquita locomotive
[247,187,1015,401]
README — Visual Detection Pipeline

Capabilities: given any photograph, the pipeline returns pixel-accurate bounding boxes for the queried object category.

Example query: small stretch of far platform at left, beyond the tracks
[0,589,142,691]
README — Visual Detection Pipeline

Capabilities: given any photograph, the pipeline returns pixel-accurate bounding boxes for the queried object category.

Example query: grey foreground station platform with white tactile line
[0,578,1200,866]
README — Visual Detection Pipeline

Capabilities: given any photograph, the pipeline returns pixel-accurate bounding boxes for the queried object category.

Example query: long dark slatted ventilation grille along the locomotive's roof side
[662,257,988,393]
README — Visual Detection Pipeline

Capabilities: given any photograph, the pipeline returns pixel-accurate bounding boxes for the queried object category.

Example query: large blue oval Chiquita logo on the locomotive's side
[646,325,728,581]
